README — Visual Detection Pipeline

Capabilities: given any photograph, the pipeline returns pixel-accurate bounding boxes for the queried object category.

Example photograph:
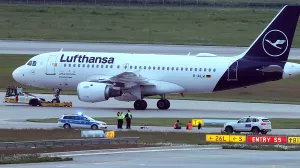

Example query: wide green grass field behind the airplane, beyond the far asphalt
[0,5,300,47]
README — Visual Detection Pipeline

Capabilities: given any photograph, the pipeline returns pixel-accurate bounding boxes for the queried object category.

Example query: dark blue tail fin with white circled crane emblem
[243,5,300,61]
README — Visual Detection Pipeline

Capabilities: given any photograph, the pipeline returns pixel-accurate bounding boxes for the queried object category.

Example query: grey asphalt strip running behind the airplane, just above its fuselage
[0,40,300,59]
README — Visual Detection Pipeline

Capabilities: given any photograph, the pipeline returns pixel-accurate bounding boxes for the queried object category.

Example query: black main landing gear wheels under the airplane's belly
[134,95,171,110]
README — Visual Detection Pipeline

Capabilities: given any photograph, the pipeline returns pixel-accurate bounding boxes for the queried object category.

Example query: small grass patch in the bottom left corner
[0,154,73,164]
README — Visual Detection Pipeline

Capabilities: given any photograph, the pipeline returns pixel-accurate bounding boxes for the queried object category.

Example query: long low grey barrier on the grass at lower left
[0,137,139,149]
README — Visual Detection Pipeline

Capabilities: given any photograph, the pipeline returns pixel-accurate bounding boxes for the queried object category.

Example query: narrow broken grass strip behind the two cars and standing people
[27,117,300,129]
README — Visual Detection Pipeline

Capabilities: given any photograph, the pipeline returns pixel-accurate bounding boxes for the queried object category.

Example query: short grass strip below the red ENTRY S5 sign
[222,144,300,151]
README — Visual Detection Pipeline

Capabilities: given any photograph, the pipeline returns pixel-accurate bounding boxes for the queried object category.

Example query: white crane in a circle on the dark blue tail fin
[262,30,288,57]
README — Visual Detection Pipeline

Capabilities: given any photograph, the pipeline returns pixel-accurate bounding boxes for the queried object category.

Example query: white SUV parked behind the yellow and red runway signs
[221,116,272,134]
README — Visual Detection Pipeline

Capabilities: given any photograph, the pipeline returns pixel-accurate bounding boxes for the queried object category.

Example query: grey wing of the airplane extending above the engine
[86,72,153,86]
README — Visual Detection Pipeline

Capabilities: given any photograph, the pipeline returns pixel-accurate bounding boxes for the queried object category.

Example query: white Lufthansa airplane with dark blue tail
[12,5,300,110]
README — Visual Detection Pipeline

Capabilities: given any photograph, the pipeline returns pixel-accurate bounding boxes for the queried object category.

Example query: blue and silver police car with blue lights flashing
[58,113,107,130]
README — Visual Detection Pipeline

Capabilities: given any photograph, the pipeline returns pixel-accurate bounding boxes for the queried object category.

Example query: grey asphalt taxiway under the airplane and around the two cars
[0,93,300,135]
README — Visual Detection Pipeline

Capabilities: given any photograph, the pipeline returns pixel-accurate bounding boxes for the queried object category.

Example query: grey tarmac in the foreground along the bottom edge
[2,146,300,168]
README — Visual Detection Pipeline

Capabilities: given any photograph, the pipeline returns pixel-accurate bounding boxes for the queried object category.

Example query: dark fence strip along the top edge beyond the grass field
[0,0,300,8]
